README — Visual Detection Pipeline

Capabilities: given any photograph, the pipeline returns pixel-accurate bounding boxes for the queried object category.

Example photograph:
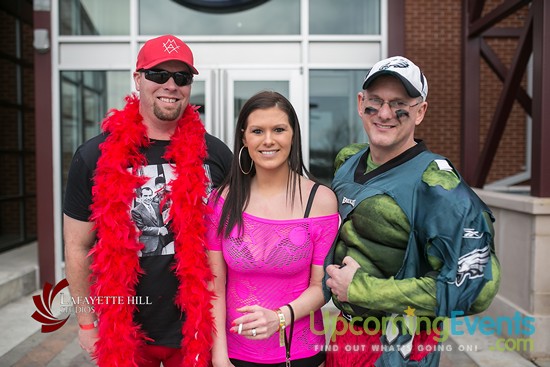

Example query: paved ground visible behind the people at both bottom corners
[0,295,550,367]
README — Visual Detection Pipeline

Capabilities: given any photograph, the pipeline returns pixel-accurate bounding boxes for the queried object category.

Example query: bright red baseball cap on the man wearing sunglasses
[136,34,199,74]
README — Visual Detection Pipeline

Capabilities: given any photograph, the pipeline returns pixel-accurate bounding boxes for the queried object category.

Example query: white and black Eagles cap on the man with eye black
[363,56,428,101]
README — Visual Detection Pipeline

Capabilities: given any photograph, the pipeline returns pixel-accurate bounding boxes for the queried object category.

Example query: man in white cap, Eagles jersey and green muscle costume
[326,56,500,367]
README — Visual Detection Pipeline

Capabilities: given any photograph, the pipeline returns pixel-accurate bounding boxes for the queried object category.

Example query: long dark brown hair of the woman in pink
[215,91,313,237]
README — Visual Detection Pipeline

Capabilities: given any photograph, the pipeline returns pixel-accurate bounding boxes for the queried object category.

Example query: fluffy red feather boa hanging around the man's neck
[90,95,213,367]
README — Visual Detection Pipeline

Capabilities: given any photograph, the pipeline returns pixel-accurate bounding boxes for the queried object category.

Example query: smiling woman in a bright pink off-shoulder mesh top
[207,91,339,367]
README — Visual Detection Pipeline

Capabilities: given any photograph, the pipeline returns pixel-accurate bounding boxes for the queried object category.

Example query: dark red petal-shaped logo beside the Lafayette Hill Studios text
[31,279,71,333]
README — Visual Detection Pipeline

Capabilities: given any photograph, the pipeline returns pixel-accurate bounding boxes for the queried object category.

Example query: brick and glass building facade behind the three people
[0,0,550,359]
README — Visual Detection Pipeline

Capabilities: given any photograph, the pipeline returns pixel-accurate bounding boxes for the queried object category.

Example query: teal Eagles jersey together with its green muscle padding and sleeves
[332,142,500,317]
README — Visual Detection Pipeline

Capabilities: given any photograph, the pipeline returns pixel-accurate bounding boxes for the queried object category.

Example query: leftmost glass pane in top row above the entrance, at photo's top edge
[59,0,130,36]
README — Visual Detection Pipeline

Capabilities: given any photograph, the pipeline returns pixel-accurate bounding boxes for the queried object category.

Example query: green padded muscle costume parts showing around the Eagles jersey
[333,145,500,317]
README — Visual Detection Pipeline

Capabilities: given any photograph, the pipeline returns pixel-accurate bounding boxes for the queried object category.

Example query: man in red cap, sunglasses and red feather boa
[63,35,231,367]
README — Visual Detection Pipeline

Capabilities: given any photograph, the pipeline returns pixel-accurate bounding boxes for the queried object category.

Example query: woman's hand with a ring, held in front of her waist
[229,305,279,340]
